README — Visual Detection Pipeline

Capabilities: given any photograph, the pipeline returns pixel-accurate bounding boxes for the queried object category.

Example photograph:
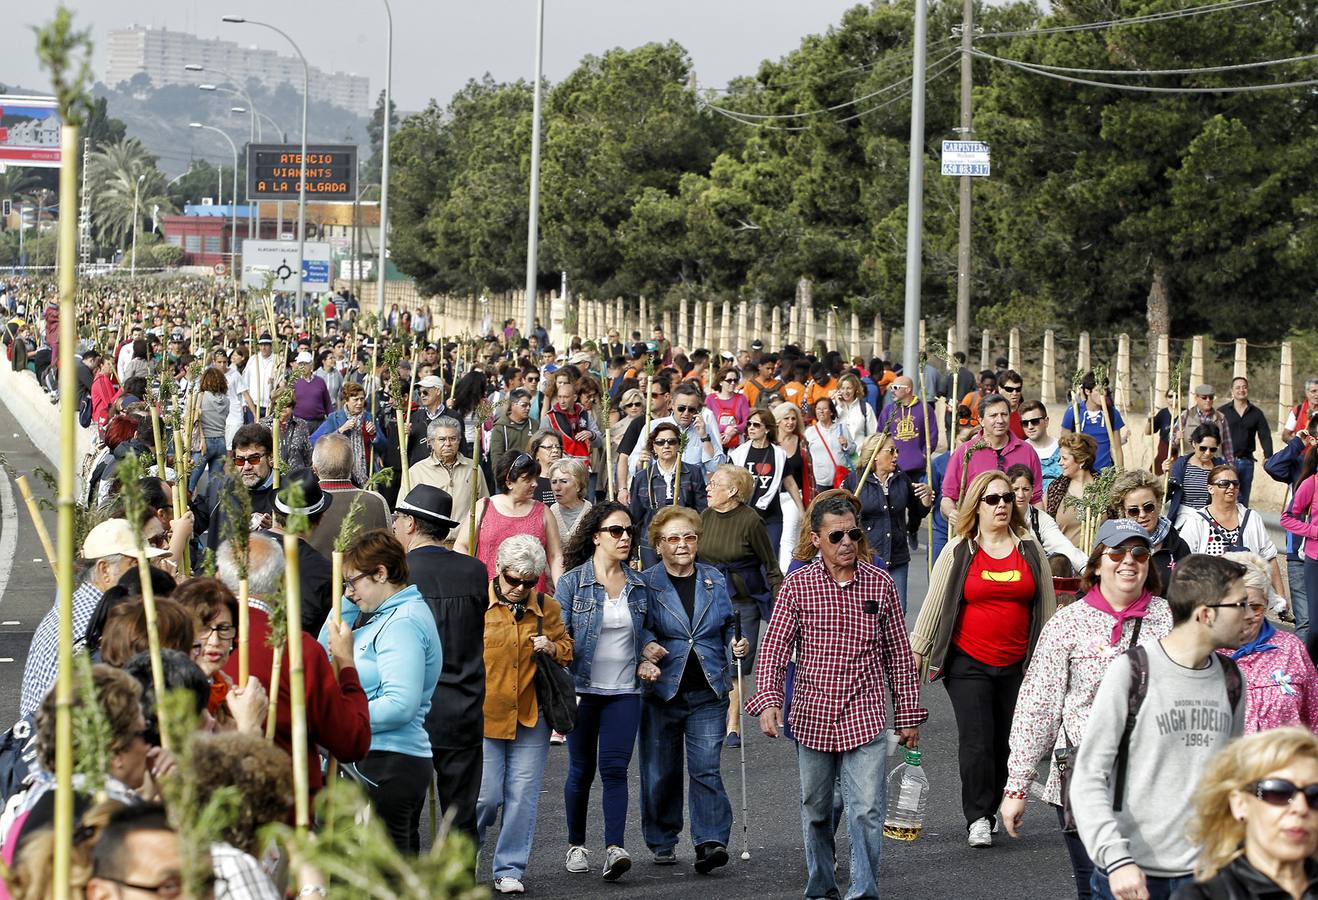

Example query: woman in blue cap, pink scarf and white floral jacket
[999,519,1172,900]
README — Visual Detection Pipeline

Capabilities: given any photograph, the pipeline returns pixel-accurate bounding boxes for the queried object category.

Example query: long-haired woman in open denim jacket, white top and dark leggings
[554,501,647,882]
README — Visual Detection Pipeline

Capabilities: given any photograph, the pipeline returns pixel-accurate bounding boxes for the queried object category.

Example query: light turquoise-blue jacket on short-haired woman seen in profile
[320,585,444,759]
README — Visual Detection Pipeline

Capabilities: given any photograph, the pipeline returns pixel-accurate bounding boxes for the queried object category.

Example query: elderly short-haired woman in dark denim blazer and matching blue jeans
[638,506,750,875]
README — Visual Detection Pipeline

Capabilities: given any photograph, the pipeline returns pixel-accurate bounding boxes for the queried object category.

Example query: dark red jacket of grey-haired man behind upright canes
[224,605,370,795]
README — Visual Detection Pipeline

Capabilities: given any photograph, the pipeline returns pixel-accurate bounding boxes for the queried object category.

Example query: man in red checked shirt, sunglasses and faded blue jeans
[746,495,929,897]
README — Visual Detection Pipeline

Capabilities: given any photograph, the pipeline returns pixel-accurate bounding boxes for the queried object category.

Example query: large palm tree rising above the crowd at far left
[87,137,174,248]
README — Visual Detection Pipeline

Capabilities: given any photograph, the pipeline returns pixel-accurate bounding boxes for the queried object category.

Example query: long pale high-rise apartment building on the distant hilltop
[105,25,372,116]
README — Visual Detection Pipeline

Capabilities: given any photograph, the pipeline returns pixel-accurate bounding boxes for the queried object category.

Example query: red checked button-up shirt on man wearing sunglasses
[746,561,929,752]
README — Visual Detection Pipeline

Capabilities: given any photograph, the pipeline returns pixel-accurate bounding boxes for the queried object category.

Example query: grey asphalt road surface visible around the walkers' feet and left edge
[0,403,1074,900]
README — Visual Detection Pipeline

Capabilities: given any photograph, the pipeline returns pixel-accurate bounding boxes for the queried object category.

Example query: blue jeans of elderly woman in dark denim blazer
[641,685,733,853]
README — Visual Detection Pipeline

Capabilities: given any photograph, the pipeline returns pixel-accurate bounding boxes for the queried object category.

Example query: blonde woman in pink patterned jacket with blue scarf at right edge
[1218,552,1318,734]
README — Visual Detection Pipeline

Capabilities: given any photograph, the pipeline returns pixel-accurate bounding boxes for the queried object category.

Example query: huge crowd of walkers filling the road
[0,281,1318,900]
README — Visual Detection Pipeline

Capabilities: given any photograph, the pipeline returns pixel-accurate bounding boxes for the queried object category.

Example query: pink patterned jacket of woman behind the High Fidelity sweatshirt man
[1218,629,1318,734]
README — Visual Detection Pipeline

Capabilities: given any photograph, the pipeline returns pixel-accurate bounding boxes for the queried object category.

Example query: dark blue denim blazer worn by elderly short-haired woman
[641,563,733,701]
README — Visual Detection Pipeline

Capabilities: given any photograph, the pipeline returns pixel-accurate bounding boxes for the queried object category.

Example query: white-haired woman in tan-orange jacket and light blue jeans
[476,535,572,893]
